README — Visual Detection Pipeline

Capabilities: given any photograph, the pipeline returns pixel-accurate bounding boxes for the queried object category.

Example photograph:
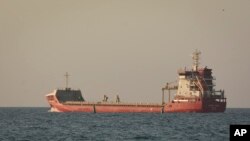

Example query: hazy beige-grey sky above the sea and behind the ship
[0,0,250,108]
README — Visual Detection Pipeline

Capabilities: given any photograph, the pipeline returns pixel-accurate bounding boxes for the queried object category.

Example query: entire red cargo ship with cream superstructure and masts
[46,50,227,113]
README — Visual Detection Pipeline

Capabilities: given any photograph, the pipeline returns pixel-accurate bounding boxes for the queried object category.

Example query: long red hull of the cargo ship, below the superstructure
[49,97,226,113]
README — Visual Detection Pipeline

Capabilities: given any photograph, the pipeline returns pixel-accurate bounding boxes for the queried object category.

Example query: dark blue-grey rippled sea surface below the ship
[0,108,250,141]
